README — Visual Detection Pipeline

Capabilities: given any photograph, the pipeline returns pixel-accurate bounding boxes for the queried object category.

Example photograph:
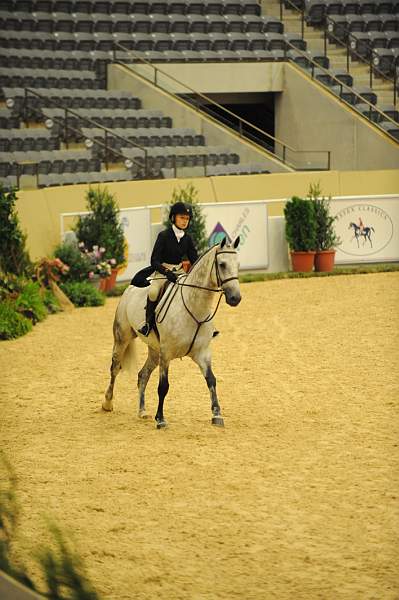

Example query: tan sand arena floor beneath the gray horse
[0,273,399,600]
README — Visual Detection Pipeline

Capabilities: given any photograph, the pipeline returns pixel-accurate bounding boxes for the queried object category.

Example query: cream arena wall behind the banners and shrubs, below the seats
[16,170,399,259]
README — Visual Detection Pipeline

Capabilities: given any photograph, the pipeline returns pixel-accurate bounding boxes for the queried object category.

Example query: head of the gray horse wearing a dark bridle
[215,237,241,306]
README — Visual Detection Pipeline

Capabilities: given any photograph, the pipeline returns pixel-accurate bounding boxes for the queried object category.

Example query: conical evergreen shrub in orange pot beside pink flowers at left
[74,186,126,291]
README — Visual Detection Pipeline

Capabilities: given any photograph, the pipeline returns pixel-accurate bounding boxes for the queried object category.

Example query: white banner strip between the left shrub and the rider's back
[117,207,152,281]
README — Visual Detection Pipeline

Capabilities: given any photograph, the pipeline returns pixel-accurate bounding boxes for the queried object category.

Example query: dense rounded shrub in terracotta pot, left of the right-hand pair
[284,196,316,272]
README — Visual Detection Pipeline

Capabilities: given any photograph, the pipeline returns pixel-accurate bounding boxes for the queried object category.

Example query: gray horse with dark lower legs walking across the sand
[102,238,241,429]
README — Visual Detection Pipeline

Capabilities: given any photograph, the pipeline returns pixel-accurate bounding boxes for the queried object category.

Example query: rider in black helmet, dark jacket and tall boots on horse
[139,202,198,336]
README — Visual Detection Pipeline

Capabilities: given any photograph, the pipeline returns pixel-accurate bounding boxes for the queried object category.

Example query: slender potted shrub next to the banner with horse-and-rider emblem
[309,184,340,272]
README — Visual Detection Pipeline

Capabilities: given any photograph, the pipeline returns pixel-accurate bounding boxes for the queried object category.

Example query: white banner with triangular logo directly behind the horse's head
[201,201,269,269]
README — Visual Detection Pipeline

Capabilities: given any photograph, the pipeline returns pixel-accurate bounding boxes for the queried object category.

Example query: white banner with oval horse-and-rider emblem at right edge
[330,195,399,264]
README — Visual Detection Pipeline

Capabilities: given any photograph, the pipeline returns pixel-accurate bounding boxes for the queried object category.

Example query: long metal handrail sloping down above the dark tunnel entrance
[113,42,331,170]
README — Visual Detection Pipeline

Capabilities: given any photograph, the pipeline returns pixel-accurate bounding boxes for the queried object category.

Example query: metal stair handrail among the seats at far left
[11,88,152,178]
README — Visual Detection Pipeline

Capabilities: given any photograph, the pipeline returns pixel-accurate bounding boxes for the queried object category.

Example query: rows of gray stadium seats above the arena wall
[0,0,399,190]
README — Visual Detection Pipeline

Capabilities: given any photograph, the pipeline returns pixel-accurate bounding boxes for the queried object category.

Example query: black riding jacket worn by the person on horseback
[151,227,198,273]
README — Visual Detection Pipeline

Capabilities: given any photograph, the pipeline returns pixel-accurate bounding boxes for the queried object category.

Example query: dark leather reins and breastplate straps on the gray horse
[154,250,238,356]
